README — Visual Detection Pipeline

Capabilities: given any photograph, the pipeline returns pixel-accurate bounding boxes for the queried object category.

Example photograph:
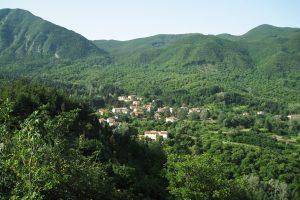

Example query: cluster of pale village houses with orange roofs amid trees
[98,95,208,140]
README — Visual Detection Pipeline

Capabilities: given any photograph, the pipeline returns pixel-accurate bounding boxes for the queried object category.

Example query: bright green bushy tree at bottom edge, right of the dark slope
[165,154,237,199]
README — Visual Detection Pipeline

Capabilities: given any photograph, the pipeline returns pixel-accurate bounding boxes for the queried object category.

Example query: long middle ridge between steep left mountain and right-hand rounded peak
[94,34,252,67]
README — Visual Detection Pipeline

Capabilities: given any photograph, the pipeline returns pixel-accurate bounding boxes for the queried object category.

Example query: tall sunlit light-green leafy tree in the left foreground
[6,112,63,199]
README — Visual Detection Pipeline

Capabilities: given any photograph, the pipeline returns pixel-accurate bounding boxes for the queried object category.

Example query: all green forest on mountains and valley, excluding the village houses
[0,9,300,200]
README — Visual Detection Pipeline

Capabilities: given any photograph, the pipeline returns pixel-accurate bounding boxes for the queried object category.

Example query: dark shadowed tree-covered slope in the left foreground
[0,81,166,199]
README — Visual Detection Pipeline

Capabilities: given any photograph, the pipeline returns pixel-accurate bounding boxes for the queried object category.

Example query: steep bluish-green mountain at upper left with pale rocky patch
[0,9,107,59]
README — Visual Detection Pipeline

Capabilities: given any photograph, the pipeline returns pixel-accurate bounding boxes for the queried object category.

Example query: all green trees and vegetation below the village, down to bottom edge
[0,81,300,199]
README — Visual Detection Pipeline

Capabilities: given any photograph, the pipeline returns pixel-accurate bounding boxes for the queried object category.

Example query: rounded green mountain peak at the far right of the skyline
[239,25,300,76]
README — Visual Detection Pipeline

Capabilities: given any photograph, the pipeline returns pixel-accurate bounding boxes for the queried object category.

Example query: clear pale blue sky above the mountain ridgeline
[0,0,300,40]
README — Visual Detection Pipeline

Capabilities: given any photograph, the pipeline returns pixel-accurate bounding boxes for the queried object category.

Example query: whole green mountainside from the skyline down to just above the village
[0,9,300,105]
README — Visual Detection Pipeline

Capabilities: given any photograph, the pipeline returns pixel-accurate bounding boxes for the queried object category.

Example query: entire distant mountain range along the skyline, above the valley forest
[0,9,300,78]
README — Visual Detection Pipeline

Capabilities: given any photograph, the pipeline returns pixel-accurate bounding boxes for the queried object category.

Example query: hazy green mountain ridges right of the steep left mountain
[94,25,300,76]
